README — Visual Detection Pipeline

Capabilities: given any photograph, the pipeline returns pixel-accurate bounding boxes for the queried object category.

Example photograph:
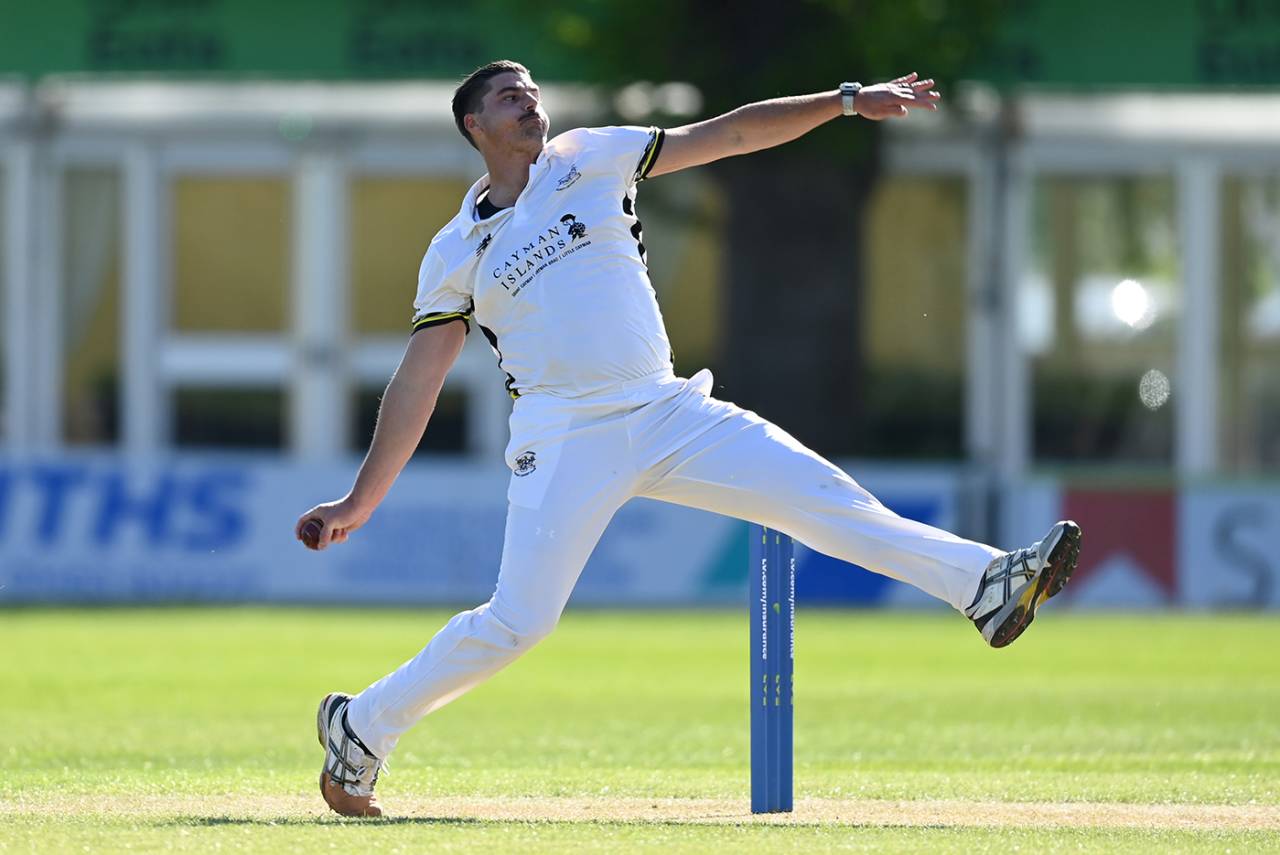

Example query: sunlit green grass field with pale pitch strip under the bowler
[0,607,1280,852]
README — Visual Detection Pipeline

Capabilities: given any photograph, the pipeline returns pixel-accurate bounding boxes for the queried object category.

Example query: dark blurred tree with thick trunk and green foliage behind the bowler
[535,0,1011,454]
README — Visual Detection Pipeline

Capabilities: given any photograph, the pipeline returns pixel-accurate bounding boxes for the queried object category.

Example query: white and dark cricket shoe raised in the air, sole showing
[964,520,1080,648]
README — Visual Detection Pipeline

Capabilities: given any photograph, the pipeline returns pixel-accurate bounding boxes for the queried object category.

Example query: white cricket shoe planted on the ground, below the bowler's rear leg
[316,691,383,817]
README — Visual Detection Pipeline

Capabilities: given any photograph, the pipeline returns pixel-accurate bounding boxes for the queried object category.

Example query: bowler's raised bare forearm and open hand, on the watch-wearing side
[649,72,941,178]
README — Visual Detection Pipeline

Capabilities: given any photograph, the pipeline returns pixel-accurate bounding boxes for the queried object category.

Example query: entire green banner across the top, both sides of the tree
[0,0,1280,88]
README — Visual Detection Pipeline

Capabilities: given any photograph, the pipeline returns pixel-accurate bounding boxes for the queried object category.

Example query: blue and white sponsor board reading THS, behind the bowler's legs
[0,454,957,605]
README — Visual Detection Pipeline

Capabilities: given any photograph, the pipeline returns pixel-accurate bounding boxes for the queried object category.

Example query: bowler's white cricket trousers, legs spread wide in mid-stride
[348,370,1000,758]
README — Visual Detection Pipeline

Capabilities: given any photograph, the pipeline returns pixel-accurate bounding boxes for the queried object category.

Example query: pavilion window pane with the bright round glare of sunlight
[1016,177,1181,467]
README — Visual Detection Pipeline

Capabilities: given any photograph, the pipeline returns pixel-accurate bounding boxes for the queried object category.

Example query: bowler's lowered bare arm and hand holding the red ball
[293,317,466,549]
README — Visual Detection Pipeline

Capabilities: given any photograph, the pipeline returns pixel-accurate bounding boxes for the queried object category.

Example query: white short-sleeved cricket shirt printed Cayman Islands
[413,127,671,398]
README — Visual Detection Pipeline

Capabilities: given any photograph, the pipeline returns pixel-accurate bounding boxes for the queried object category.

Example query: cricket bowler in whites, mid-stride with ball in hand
[294,60,1080,817]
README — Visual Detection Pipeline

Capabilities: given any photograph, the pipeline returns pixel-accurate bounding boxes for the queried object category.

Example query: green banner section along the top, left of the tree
[0,0,586,79]
